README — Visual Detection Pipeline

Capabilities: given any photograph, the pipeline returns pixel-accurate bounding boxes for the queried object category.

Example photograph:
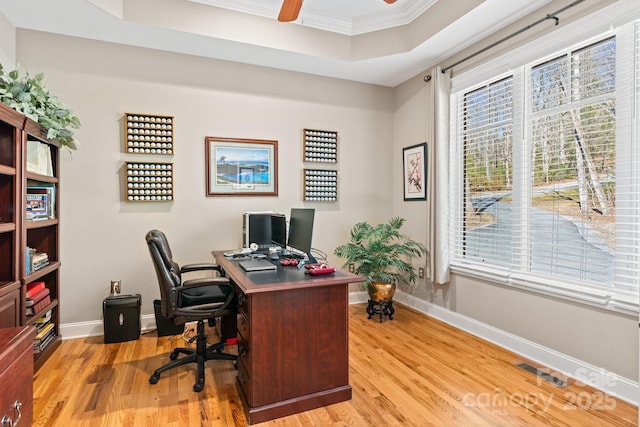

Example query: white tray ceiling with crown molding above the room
[0,0,552,87]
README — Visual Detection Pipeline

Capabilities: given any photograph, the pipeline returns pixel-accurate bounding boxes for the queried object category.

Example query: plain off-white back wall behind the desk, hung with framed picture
[17,30,393,324]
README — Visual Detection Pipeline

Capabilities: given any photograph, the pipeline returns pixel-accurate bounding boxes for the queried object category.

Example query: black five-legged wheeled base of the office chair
[149,320,238,392]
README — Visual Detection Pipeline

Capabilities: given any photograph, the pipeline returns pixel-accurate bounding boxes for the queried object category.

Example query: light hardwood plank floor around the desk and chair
[33,304,638,427]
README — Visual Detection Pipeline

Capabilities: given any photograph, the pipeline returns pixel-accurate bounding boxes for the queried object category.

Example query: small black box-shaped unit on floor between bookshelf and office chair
[102,294,142,344]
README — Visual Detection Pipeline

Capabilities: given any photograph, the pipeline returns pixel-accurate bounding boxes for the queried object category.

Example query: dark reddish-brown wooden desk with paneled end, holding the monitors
[214,252,363,424]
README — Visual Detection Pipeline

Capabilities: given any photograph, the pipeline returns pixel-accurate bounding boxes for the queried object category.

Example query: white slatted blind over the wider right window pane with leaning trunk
[523,37,617,285]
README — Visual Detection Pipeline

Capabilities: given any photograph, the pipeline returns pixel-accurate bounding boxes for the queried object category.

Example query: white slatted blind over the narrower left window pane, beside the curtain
[455,77,513,266]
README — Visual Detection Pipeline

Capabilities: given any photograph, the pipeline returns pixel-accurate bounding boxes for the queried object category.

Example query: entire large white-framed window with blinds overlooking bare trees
[450,20,640,306]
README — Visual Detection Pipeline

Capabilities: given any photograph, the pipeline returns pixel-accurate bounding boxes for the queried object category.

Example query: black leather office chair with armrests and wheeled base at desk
[146,230,237,391]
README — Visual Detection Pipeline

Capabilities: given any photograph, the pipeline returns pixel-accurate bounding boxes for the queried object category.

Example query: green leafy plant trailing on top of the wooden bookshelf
[0,65,80,150]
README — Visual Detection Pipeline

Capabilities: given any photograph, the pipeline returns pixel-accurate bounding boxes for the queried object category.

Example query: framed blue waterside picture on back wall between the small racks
[204,136,278,196]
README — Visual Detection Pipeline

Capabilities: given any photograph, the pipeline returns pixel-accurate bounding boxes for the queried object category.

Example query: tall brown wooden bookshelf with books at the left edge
[0,103,61,369]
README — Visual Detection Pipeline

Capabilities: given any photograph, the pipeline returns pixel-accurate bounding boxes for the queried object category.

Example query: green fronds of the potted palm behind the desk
[334,217,428,289]
